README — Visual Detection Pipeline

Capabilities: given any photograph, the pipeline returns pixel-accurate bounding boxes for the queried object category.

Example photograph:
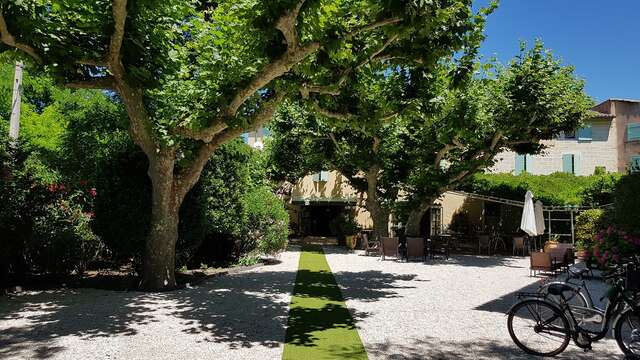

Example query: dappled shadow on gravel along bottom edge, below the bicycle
[366,337,624,360]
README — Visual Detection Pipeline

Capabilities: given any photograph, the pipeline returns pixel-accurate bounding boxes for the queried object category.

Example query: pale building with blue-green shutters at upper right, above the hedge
[489,99,640,175]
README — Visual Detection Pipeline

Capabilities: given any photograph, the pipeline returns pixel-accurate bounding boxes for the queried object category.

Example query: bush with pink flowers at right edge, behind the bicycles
[591,226,640,266]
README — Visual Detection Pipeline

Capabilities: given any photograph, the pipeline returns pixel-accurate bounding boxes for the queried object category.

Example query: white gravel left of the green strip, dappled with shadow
[0,251,299,360]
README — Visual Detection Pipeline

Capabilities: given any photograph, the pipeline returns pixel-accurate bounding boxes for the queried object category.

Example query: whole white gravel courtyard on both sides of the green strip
[0,247,622,360]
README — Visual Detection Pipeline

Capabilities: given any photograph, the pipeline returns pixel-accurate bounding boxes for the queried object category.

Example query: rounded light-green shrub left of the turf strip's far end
[240,187,289,254]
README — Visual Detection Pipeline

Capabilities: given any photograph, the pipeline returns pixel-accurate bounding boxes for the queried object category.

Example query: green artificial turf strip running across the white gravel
[282,245,367,360]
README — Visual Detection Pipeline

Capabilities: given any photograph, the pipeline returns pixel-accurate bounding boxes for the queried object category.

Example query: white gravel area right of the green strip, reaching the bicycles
[325,247,623,360]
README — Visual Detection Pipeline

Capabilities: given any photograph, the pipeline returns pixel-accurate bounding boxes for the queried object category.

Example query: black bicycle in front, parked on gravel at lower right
[507,266,640,356]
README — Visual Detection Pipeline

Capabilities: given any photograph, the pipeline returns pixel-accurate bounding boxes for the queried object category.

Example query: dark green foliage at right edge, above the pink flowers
[614,174,640,235]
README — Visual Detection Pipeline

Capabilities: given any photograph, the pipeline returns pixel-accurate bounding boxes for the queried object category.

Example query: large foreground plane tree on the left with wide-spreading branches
[0,0,490,290]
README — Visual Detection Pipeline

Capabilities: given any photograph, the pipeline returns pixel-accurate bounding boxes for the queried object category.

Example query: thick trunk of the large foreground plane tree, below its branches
[140,151,182,291]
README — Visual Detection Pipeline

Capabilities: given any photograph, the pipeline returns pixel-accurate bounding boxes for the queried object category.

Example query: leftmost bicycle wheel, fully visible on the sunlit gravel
[507,299,571,356]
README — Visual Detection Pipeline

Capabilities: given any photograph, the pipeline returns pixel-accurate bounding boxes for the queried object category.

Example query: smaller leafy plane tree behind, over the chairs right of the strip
[272,43,591,236]
